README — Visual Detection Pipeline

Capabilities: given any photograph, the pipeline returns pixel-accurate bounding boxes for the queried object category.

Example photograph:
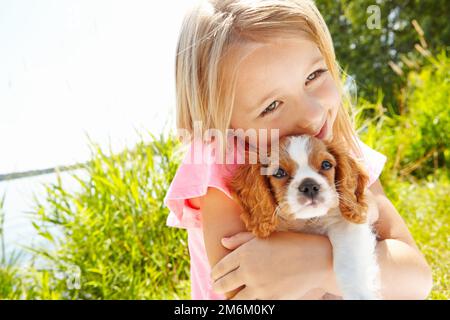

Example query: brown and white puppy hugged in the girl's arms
[227,135,380,300]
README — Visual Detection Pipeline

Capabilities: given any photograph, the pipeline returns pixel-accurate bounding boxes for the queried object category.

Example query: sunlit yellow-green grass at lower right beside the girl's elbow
[385,175,450,300]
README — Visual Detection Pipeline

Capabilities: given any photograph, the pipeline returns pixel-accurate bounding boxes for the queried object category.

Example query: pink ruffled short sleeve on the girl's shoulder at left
[164,138,239,229]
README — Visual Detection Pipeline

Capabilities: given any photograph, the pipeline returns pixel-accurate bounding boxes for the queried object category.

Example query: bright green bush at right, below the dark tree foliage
[357,52,450,179]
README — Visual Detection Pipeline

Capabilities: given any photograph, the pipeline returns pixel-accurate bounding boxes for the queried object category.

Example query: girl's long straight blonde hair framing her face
[175,0,362,157]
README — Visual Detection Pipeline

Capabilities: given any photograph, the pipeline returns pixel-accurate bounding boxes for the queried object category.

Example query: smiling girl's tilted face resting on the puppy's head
[231,38,341,145]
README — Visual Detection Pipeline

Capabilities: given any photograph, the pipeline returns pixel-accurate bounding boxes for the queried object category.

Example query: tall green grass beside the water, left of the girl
[0,131,190,299]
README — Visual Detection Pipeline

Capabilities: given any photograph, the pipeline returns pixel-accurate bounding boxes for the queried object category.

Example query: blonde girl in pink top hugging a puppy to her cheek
[165,0,432,299]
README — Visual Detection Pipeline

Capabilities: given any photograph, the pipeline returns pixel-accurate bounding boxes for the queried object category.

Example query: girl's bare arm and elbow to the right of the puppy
[324,180,432,299]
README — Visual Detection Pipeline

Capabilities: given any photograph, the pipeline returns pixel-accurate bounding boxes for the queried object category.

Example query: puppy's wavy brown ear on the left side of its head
[227,153,278,238]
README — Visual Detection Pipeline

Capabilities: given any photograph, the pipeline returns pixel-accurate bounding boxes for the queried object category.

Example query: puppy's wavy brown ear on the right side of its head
[328,143,369,223]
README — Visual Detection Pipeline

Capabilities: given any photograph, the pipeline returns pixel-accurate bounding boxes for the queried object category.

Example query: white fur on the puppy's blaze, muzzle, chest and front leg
[279,136,380,300]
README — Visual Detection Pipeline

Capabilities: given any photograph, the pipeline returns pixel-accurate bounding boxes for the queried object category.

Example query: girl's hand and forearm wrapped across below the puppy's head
[211,232,332,300]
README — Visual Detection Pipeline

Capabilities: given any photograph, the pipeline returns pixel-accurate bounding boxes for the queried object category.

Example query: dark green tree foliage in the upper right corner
[315,0,450,111]
